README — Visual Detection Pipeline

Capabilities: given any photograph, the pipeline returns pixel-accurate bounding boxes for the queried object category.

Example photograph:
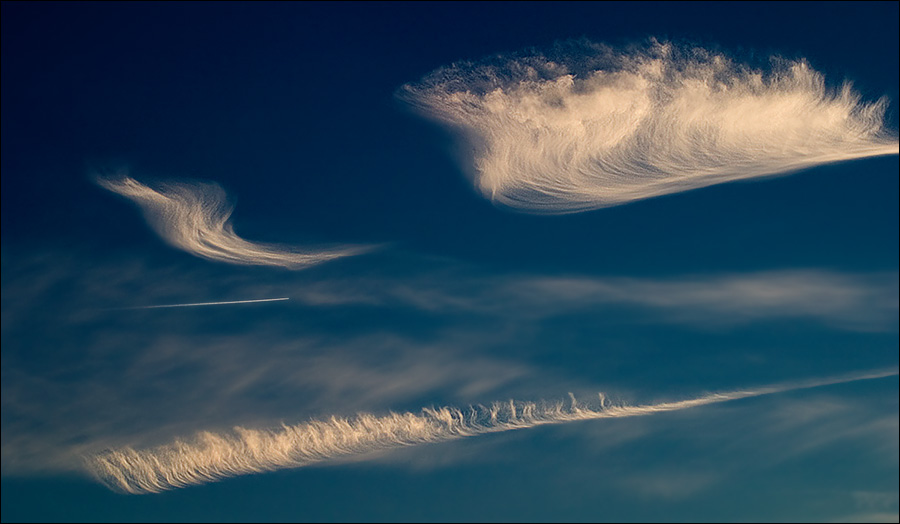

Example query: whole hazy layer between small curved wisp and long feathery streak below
[0,249,897,482]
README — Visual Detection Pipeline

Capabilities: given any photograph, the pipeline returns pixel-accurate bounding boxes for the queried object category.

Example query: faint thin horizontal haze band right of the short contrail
[268,269,900,331]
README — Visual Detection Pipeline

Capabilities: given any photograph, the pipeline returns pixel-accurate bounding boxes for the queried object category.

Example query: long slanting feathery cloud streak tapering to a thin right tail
[86,369,898,493]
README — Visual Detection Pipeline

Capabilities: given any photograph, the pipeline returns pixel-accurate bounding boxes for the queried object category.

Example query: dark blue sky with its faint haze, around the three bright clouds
[0,2,900,521]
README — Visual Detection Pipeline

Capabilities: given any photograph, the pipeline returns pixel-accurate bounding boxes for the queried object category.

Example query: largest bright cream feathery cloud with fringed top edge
[398,41,898,213]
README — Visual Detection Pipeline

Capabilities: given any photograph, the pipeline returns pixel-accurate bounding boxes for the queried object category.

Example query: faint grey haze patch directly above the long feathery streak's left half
[2,330,540,474]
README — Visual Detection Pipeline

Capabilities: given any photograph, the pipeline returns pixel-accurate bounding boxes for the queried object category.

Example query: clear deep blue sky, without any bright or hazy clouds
[0,2,900,521]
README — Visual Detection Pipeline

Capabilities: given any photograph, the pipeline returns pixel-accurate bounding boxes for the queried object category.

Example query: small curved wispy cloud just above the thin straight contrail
[97,176,371,269]
